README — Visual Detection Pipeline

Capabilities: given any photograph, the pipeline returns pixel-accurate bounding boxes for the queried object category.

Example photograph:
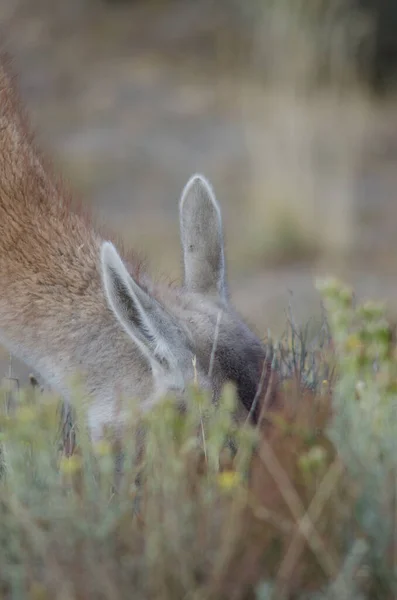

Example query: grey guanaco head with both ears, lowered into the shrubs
[101,175,266,416]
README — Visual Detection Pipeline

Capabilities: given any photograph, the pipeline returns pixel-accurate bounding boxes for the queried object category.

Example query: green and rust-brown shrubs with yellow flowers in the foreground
[0,282,397,600]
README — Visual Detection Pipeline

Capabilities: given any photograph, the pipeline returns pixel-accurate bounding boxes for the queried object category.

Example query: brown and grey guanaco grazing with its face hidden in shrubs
[0,56,266,439]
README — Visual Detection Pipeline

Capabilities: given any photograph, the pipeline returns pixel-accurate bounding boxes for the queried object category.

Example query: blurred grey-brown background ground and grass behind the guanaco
[0,0,397,380]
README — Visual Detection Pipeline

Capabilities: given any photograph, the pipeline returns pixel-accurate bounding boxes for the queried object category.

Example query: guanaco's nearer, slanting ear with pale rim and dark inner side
[101,242,175,366]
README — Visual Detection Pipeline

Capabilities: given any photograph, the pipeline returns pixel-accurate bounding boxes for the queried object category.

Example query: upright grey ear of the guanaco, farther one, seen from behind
[179,175,227,301]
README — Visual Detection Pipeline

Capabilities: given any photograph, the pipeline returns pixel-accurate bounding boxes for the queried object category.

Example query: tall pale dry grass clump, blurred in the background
[241,0,376,260]
